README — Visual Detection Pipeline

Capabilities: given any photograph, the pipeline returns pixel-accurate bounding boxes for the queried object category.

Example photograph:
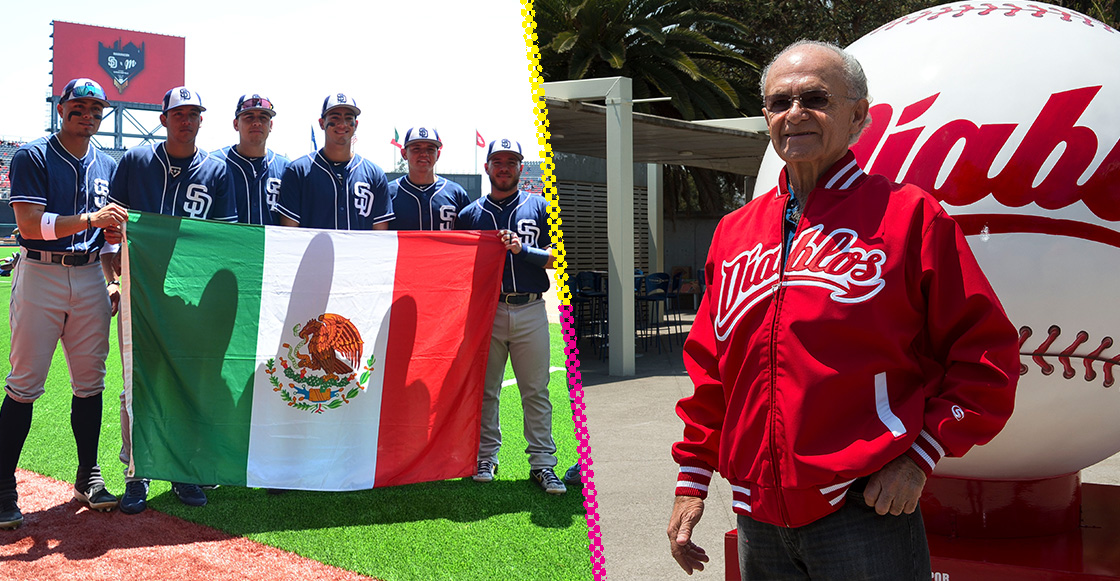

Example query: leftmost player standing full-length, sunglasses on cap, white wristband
[0,78,128,528]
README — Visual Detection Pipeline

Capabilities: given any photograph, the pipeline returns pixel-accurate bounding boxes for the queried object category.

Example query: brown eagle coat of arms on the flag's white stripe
[264,312,374,413]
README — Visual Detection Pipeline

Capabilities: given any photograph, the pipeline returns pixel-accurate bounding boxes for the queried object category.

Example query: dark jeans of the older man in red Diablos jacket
[738,491,930,581]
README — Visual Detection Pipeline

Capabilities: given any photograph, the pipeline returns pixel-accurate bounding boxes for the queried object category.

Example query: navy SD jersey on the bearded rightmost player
[458,191,552,292]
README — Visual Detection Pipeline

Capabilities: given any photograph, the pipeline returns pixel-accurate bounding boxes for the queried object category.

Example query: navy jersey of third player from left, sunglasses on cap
[211,146,290,226]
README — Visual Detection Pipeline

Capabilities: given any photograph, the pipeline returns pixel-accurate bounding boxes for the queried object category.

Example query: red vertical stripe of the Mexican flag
[374,232,505,487]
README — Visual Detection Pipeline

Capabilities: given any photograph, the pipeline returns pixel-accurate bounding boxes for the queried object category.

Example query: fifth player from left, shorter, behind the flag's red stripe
[389,128,470,231]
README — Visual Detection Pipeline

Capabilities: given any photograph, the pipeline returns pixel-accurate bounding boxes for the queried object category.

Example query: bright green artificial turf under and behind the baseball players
[0,249,592,581]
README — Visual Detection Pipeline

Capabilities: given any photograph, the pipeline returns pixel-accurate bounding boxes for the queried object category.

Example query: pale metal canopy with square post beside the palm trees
[541,77,769,375]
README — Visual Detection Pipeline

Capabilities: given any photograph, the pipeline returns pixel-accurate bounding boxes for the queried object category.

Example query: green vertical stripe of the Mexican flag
[128,213,264,484]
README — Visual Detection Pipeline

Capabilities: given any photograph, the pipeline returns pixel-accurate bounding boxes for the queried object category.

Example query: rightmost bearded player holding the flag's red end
[458,139,568,495]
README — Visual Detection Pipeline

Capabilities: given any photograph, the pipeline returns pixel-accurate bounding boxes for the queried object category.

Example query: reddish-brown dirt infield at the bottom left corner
[0,470,372,581]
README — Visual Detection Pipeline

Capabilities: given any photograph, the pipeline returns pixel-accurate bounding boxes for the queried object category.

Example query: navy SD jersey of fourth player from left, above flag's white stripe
[277,150,393,229]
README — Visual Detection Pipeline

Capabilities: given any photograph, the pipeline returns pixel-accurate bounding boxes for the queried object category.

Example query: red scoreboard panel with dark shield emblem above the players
[52,20,187,105]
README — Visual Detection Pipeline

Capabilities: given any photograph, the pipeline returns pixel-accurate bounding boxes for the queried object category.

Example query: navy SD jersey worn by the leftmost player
[9,134,116,252]
